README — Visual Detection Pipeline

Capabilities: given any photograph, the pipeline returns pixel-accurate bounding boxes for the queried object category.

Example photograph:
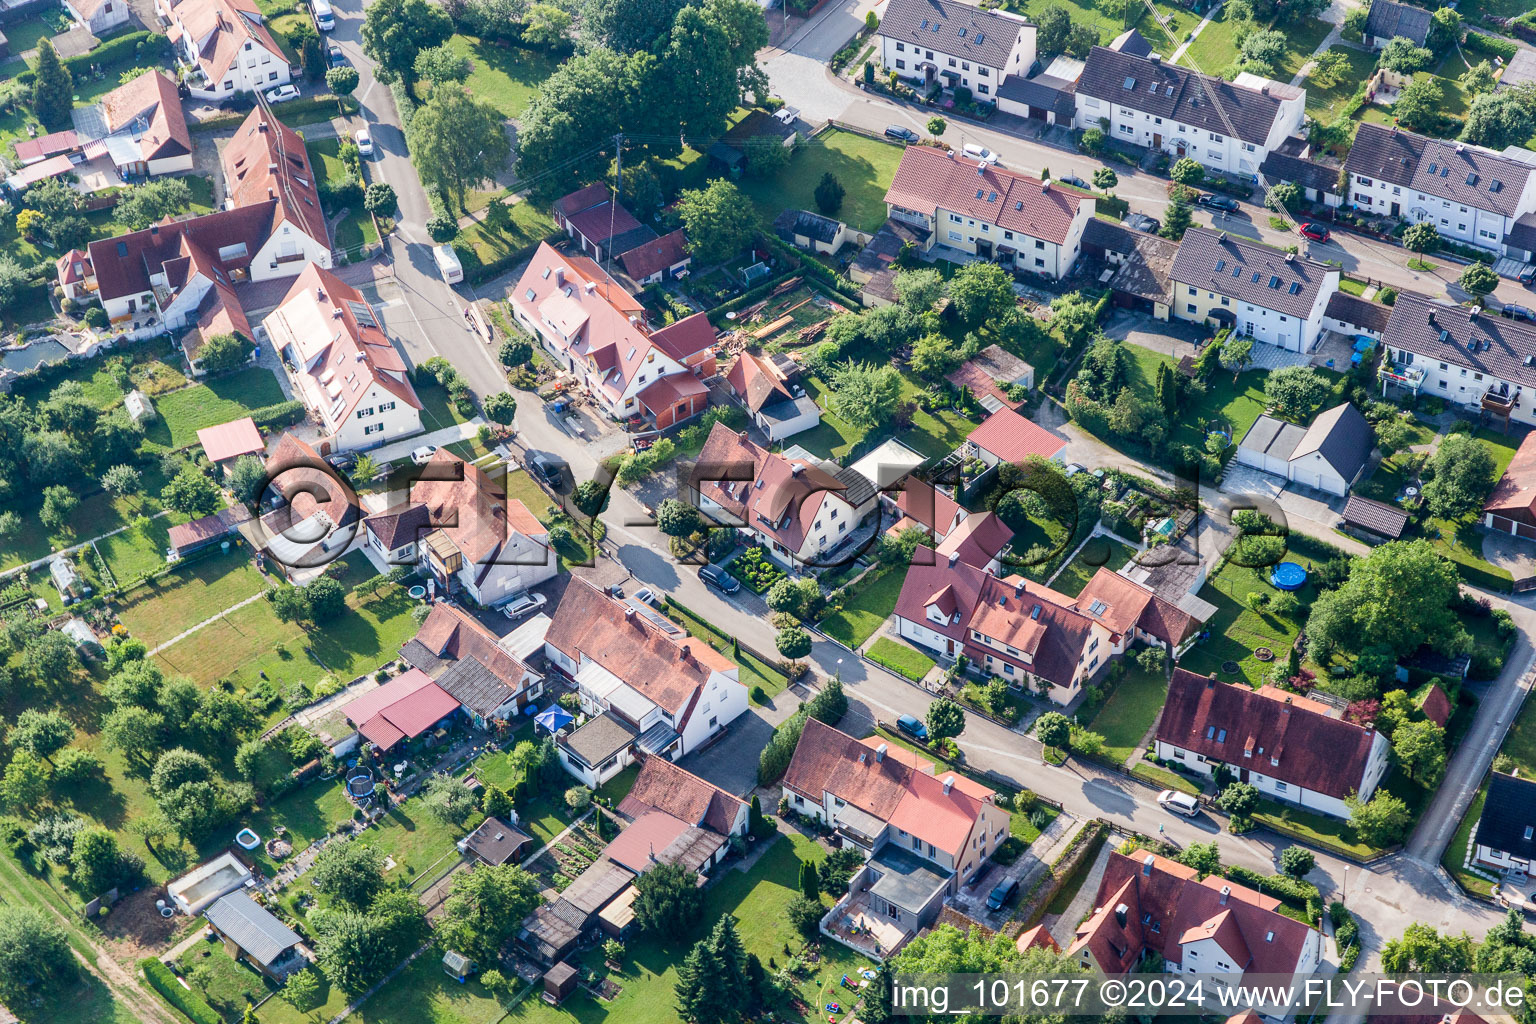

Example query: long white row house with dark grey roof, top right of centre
[1075,46,1307,180]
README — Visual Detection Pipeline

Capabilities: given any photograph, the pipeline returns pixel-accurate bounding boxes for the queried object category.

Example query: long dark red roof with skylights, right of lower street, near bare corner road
[1157,668,1376,800]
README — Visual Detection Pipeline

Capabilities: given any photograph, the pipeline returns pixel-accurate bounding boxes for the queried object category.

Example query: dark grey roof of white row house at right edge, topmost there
[1344,121,1533,220]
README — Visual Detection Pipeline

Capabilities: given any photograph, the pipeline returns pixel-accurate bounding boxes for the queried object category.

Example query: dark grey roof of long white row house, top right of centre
[1077,46,1279,144]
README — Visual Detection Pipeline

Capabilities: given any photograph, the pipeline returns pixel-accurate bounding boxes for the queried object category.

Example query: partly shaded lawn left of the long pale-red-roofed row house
[740,129,902,232]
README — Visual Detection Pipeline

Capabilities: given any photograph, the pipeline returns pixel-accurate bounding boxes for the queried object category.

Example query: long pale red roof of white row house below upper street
[882,144,1092,244]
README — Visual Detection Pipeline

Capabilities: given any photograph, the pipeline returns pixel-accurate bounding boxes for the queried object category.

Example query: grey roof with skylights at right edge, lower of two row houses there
[1381,292,1536,387]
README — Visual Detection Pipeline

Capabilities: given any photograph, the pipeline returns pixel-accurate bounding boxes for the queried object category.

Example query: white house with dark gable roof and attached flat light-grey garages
[1236,402,1376,496]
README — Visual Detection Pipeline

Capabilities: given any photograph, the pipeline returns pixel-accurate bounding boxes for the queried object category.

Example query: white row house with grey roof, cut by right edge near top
[1344,122,1536,261]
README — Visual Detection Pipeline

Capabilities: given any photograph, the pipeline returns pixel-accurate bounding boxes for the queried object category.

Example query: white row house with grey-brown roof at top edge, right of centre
[876,0,1035,103]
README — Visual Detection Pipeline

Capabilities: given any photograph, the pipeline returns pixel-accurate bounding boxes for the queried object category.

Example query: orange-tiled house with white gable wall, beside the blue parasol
[544,579,746,785]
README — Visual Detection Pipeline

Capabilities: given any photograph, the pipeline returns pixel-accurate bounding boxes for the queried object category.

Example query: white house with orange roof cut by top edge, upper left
[155,0,292,99]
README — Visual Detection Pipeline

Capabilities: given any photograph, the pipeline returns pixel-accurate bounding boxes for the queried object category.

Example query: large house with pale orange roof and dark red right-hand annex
[511,243,716,430]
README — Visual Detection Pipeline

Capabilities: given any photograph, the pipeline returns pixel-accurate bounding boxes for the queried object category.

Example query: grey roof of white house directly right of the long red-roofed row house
[1169,227,1338,319]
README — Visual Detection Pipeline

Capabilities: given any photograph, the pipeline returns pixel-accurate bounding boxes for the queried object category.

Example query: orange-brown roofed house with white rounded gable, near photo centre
[688,424,879,565]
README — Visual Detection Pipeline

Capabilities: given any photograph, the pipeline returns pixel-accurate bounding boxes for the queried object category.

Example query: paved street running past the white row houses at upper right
[759,0,1531,306]
